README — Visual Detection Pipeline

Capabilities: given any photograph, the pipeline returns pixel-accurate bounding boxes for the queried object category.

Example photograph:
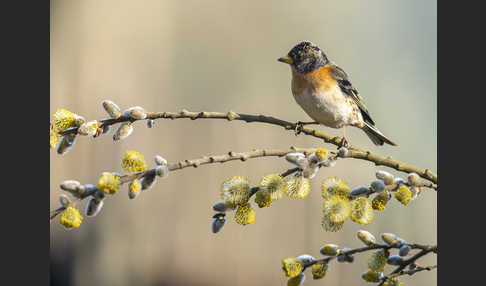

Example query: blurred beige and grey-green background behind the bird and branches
[50,0,437,286]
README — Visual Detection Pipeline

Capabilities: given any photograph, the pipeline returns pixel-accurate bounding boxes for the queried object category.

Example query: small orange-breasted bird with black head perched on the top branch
[278,41,397,146]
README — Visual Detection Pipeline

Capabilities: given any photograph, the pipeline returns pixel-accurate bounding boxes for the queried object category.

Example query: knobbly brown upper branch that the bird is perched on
[61,110,437,185]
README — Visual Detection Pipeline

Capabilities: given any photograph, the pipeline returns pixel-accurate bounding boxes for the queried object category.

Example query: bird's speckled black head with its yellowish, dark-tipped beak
[278,41,329,74]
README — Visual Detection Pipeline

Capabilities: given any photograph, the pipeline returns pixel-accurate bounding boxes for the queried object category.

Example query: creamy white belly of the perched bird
[293,86,363,128]
